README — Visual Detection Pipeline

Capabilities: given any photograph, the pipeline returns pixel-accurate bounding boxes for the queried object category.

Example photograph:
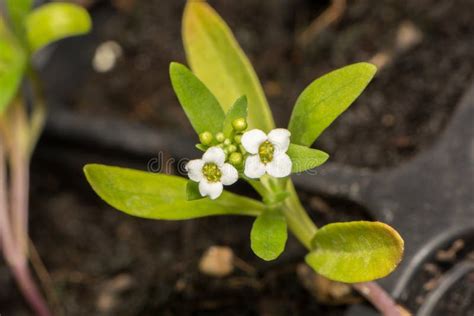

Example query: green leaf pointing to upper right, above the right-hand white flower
[288,63,377,146]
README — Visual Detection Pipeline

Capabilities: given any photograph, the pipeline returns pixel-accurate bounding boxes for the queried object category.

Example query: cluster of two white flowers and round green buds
[186,118,292,199]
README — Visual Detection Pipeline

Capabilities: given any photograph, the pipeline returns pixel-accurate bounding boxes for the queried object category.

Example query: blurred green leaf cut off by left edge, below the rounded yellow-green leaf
[0,16,26,114]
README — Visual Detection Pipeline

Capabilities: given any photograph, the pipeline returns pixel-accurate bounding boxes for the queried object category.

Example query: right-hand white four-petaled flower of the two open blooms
[242,128,292,179]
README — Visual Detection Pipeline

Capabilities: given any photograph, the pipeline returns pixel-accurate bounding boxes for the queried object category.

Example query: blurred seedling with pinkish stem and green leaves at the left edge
[0,0,91,316]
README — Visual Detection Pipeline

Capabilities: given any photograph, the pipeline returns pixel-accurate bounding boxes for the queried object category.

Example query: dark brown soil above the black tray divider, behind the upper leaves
[71,0,474,168]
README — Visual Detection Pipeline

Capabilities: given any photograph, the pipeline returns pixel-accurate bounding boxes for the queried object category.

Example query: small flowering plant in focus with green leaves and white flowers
[84,1,403,314]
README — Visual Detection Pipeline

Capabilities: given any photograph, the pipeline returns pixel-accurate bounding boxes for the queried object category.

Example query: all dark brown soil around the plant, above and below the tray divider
[0,0,474,316]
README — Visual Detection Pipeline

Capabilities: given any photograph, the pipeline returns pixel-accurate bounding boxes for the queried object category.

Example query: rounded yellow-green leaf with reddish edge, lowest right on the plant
[306,221,403,283]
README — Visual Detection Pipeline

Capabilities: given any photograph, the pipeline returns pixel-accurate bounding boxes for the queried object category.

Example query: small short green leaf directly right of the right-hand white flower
[287,144,329,173]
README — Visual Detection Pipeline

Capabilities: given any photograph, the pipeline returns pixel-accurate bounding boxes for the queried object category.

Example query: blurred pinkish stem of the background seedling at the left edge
[0,100,51,316]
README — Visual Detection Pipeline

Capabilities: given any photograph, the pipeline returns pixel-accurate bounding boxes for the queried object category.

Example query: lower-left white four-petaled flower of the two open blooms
[186,147,239,200]
